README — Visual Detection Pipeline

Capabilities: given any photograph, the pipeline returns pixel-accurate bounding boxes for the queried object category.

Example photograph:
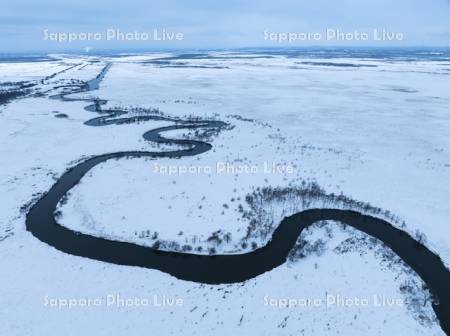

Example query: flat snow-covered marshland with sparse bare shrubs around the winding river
[0,50,450,335]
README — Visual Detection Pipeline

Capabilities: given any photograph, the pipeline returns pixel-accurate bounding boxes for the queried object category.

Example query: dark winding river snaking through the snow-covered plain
[26,64,450,335]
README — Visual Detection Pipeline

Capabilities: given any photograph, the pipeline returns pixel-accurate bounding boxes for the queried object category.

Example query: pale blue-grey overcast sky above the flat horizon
[0,0,450,52]
